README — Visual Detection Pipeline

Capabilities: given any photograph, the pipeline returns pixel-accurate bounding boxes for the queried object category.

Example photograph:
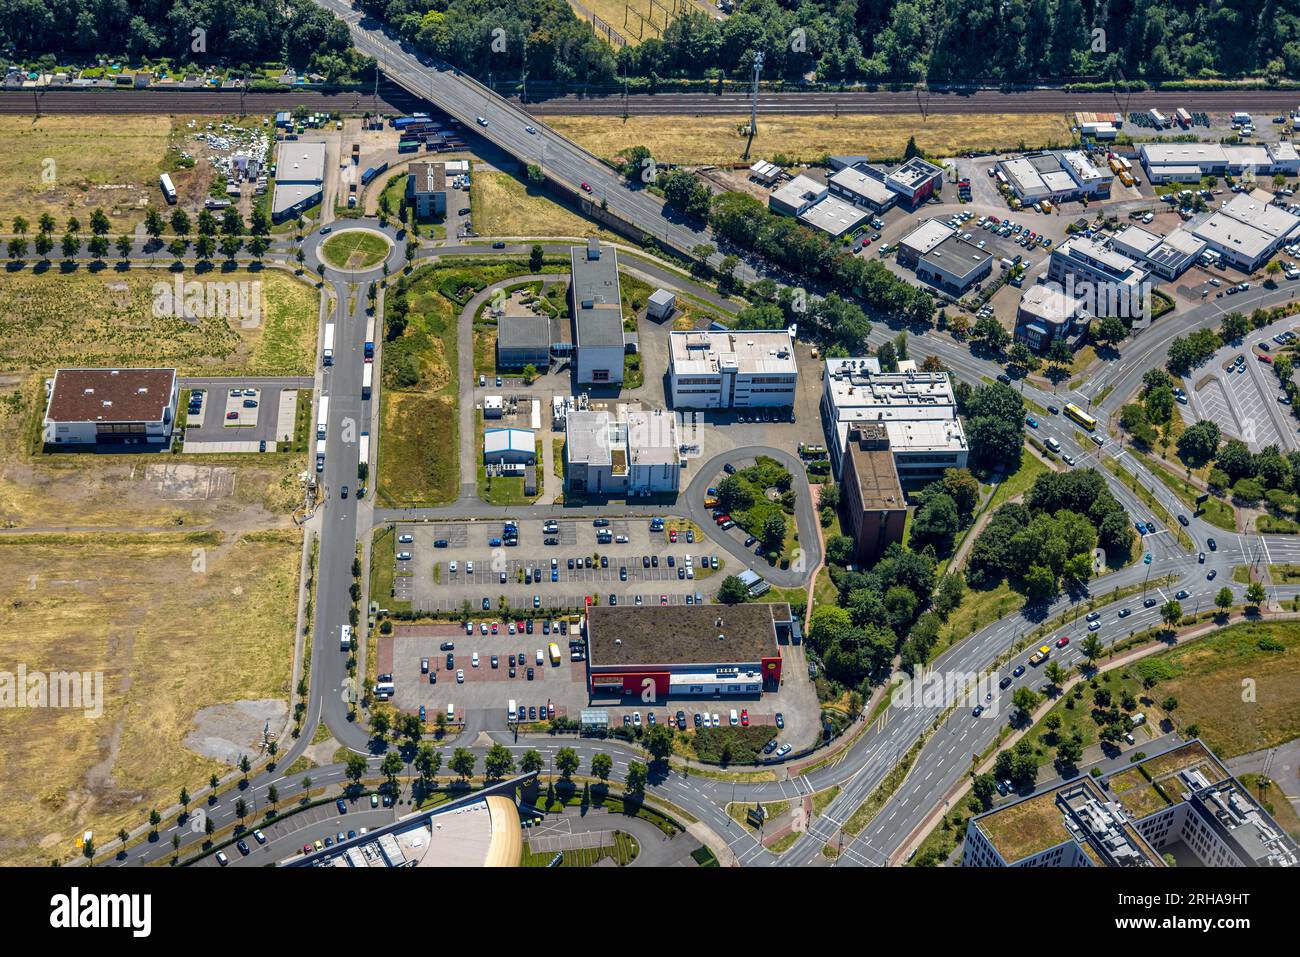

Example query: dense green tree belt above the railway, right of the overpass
[363,0,1300,91]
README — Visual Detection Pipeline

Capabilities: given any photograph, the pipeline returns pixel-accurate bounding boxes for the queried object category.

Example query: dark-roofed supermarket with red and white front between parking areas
[585,602,794,702]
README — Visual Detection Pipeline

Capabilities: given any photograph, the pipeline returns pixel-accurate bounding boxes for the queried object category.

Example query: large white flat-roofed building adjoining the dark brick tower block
[822,356,970,482]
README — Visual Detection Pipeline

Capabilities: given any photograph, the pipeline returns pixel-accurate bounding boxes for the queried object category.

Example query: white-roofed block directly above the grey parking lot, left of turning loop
[564,408,681,495]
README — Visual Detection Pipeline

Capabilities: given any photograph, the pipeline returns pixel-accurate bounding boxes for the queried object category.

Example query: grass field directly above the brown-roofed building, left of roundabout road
[0,268,320,376]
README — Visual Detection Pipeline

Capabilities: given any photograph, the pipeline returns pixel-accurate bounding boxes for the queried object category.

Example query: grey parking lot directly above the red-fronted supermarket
[394,519,725,615]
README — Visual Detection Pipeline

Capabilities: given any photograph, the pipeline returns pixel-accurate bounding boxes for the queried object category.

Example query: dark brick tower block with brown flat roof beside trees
[840,423,907,564]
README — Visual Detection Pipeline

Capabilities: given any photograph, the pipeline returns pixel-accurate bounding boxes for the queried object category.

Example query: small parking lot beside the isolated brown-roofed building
[185,380,302,452]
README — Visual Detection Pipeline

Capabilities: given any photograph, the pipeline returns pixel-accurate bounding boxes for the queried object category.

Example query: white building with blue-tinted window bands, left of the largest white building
[668,329,798,408]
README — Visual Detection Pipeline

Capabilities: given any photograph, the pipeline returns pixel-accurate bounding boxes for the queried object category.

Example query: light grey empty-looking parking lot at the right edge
[1183,320,1300,451]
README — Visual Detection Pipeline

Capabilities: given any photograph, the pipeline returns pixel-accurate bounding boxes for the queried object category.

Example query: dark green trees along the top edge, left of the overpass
[0,0,369,79]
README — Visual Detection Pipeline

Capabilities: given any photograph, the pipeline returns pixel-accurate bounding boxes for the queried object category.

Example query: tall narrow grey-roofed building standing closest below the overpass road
[568,239,625,385]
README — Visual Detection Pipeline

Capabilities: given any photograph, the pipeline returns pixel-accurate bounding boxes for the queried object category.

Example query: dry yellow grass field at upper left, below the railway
[0,116,172,230]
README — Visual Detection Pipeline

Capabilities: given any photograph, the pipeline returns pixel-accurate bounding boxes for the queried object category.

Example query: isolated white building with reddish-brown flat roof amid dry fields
[42,369,179,446]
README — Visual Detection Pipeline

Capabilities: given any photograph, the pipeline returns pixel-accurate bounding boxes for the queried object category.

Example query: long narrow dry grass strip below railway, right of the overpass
[546,113,1070,165]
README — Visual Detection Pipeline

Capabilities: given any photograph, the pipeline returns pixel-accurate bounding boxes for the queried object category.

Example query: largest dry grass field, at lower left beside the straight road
[0,531,302,865]
